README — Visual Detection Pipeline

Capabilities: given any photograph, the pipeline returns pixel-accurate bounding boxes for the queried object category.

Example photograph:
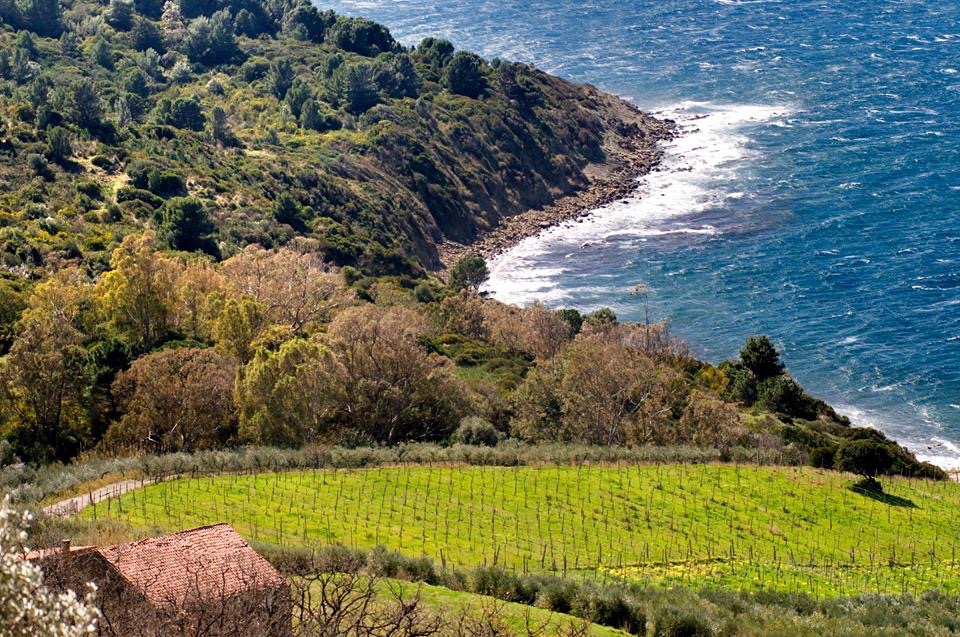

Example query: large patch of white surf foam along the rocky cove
[485,101,793,305]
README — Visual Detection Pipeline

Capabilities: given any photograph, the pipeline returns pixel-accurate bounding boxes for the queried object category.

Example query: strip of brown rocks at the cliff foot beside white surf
[438,114,676,269]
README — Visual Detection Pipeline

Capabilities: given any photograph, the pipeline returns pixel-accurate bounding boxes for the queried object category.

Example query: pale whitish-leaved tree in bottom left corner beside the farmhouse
[0,496,100,637]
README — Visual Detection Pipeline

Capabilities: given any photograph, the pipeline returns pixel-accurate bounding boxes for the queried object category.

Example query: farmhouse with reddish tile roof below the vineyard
[28,524,291,637]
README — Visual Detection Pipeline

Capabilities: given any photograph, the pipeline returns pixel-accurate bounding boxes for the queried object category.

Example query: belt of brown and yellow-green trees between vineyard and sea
[0,232,945,488]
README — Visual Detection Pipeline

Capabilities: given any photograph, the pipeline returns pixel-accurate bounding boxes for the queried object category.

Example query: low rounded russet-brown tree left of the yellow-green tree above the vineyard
[106,348,237,453]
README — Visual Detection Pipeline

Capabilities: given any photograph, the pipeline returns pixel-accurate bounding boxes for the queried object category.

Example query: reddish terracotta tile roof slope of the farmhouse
[98,524,286,607]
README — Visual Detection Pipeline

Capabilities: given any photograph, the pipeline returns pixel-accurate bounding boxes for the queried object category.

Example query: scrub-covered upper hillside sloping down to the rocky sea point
[0,0,669,276]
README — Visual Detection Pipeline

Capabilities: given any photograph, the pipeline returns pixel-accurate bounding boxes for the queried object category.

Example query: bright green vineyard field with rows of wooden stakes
[83,465,960,596]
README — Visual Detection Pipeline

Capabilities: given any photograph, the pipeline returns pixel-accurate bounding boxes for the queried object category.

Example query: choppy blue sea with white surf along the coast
[322,0,960,466]
